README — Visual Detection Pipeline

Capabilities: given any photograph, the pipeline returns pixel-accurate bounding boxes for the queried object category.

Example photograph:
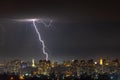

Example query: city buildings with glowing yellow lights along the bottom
[0,58,120,80]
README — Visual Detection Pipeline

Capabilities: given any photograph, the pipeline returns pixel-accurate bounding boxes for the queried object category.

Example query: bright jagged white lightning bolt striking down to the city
[32,19,48,61]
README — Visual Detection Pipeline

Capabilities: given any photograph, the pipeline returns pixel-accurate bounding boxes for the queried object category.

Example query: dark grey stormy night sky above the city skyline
[0,0,120,61]
